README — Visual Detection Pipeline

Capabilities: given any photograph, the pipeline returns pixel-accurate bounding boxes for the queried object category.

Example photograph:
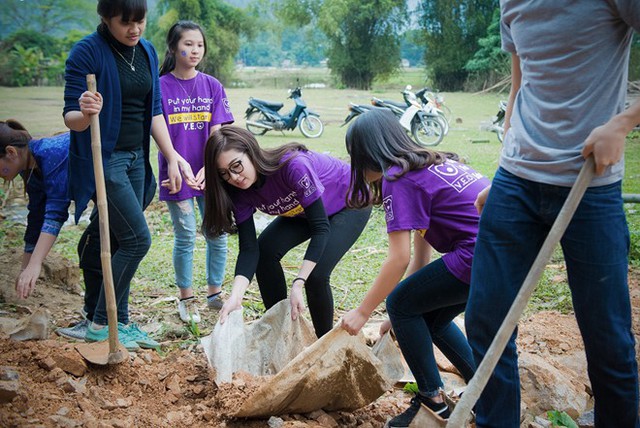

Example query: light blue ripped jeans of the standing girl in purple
[167,196,227,288]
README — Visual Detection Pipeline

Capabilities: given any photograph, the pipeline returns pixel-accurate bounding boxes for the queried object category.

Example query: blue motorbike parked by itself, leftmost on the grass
[245,86,324,138]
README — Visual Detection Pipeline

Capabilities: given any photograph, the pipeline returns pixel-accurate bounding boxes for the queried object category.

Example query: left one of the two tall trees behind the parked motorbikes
[276,0,407,89]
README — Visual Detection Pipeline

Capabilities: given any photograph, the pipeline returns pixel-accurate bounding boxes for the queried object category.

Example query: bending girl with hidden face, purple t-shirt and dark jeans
[342,110,489,427]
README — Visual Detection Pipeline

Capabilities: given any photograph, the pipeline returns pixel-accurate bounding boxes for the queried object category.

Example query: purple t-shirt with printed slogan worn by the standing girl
[158,72,233,201]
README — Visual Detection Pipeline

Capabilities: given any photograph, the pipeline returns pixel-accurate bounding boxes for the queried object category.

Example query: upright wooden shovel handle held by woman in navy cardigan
[87,74,118,354]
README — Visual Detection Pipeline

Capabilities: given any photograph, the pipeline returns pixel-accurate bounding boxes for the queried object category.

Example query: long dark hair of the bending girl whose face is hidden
[345,109,458,208]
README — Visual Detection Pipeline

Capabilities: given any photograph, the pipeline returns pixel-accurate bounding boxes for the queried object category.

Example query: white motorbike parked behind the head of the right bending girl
[341,90,444,146]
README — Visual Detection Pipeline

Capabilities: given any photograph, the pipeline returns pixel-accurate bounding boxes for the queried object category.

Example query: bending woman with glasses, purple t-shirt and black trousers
[204,126,371,337]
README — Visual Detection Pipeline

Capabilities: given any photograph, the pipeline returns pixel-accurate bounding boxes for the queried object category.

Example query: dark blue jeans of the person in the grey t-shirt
[465,169,640,428]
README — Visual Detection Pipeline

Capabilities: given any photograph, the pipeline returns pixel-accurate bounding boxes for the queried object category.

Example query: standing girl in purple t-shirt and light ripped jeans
[158,21,233,323]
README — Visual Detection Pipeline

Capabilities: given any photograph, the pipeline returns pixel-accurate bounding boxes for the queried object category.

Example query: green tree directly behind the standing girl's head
[149,0,250,83]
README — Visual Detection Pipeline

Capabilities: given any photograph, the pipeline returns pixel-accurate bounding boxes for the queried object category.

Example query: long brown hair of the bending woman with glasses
[202,126,307,238]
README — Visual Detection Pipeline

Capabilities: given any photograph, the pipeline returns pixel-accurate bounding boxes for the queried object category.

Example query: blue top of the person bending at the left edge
[21,132,71,253]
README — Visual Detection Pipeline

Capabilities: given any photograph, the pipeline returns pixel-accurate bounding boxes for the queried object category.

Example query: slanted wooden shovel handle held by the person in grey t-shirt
[447,156,595,428]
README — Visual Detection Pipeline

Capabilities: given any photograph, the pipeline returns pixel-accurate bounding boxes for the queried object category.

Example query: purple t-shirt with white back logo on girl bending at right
[382,160,489,284]
